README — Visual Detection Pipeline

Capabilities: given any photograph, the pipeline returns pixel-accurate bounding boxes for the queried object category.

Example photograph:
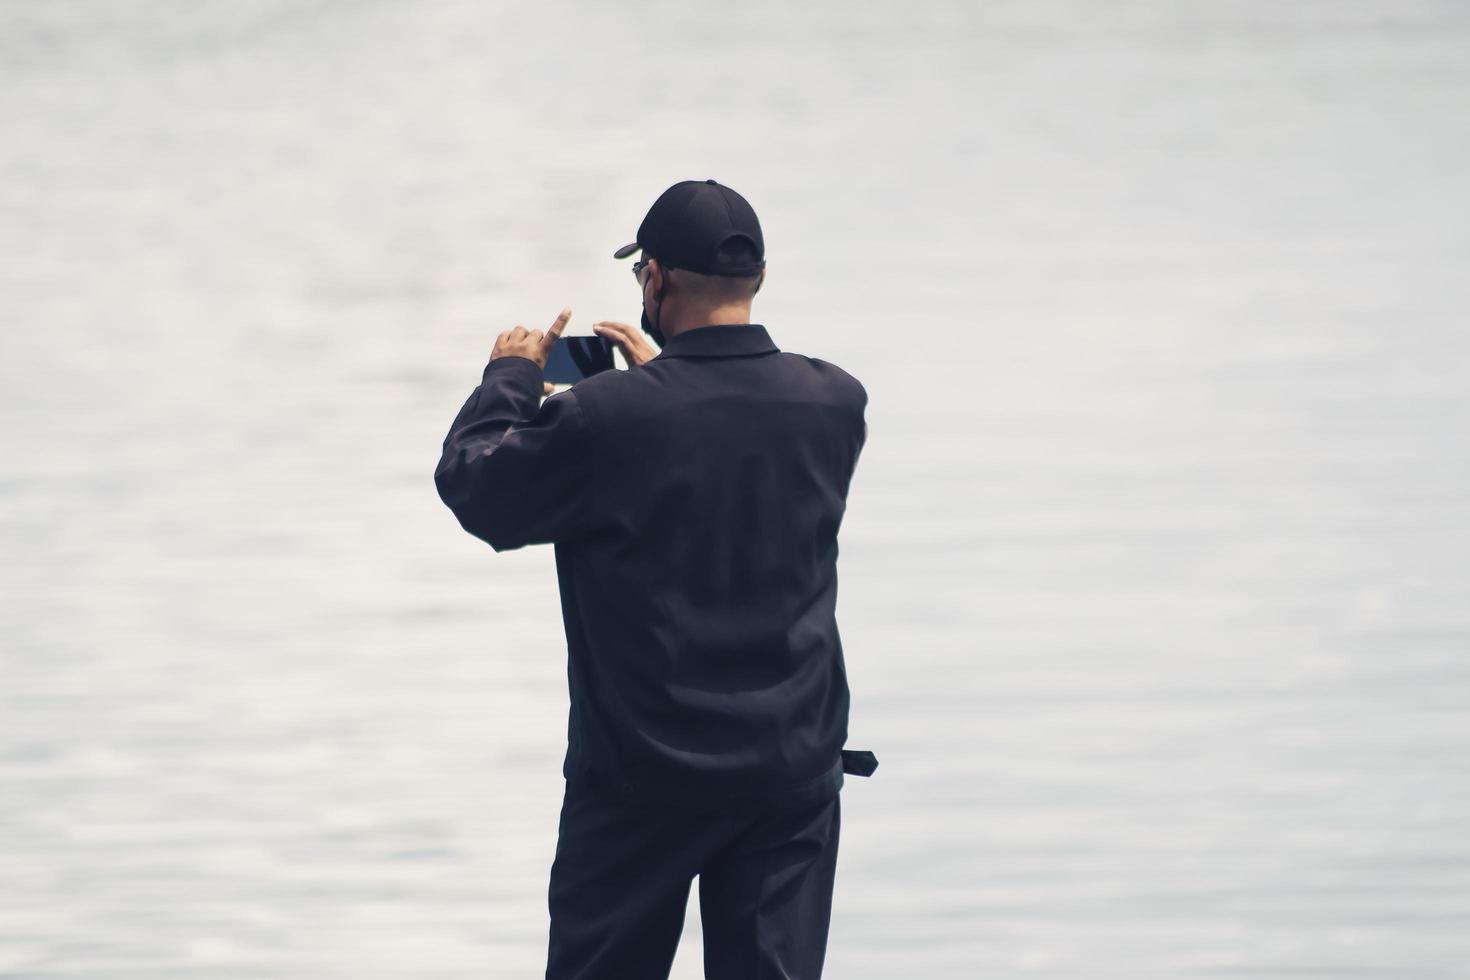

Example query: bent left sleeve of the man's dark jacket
[434,356,597,551]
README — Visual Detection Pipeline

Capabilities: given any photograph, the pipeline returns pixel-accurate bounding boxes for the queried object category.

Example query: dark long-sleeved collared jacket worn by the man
[434,323,878,813]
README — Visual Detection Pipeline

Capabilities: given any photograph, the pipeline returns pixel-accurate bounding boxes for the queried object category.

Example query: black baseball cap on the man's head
[613,181,766,276]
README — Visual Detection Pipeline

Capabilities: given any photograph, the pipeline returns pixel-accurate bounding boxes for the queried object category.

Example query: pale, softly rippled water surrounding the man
[0,0,1470,980]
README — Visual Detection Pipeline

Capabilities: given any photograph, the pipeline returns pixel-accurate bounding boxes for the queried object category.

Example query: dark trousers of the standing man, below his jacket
[547,779,841,980]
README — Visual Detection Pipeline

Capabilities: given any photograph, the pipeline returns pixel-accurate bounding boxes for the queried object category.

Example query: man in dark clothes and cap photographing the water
[434,181,878,980]
